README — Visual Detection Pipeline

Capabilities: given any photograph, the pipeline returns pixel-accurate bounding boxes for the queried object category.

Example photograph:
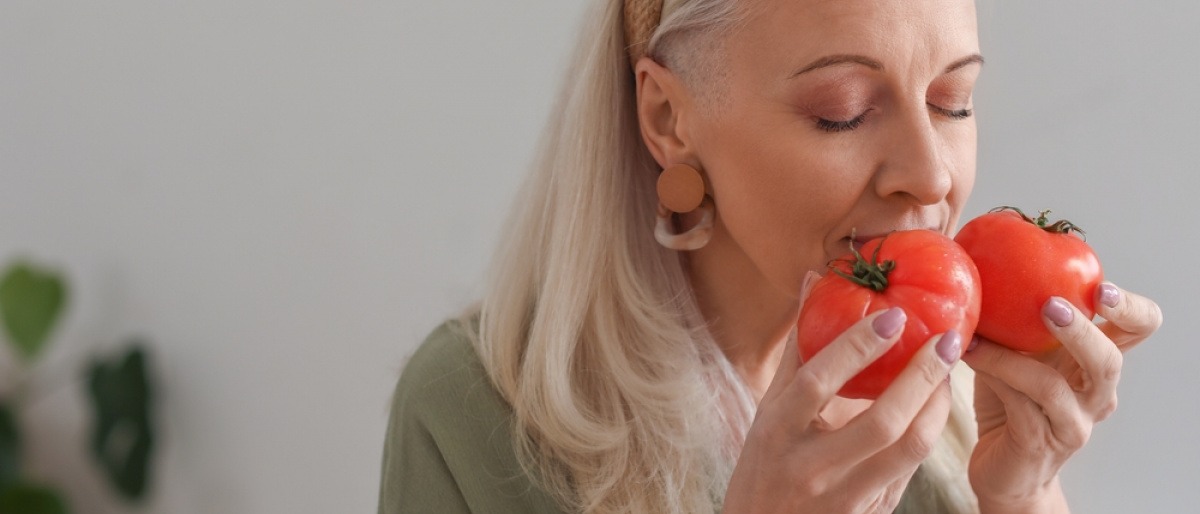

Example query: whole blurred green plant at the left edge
[0,261,154,514]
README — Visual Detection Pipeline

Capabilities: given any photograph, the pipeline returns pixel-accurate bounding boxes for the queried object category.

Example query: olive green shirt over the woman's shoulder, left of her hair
[379,322,562,514]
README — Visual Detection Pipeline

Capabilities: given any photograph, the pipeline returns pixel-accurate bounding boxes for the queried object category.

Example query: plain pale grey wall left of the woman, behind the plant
[0,0,590,513]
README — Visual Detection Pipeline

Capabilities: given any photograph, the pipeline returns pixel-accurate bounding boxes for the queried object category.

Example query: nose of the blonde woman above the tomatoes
[875,109,954,205]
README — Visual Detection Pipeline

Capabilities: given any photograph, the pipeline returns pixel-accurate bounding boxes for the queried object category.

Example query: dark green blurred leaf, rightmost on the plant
[88,343,154,500]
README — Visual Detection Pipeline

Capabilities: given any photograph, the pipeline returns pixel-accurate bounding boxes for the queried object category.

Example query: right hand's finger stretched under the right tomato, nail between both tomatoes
[962,339,1082,428]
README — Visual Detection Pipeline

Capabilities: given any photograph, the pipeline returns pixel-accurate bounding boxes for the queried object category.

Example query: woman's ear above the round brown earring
[634,58,698,168]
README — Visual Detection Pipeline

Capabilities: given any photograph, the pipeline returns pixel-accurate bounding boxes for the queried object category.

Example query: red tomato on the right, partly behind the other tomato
[954,207,1104,353]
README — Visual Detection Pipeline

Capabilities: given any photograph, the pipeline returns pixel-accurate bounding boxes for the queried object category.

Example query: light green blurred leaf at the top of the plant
[0,262,66,360]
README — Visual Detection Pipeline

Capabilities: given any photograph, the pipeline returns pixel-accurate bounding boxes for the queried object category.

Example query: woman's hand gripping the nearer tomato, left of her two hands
[725,295,962,514]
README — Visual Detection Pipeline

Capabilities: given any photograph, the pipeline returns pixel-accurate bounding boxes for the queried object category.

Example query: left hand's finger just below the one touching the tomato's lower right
[848,381,953,494]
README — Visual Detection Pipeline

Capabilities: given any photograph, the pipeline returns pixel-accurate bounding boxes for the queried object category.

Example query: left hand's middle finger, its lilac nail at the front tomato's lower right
[833,331,962,462]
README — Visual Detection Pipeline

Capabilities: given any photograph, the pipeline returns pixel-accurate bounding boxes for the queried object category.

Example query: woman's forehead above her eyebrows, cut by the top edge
[731,0,979,71]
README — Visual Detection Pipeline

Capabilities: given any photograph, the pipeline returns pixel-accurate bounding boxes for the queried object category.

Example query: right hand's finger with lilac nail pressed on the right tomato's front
[1042,297,1124,404]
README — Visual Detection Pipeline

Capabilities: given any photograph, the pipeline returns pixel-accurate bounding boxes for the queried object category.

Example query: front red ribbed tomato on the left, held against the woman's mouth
[796,231,979,399]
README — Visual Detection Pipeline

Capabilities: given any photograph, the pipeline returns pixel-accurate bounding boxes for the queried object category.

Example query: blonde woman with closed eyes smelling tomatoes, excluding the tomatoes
[380,0,1160,513]
